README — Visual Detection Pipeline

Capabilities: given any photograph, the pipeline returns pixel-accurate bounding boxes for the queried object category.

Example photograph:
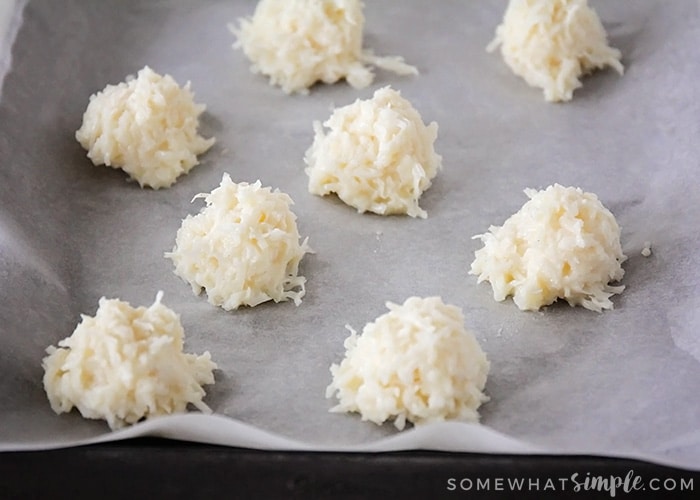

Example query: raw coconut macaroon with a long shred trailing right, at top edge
[229,0,418,94]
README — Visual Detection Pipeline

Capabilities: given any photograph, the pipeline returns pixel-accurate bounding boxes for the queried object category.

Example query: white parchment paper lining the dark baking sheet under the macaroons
[0,0,700,469]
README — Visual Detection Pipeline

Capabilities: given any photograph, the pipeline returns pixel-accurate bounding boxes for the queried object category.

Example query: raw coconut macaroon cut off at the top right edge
[487,0,624,101]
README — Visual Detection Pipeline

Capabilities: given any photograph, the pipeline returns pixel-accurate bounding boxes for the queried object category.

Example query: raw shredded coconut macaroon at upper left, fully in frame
[75,66,214,189]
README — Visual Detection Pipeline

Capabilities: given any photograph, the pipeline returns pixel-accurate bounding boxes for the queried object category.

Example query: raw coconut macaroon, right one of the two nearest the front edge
[326,297,489,430]
